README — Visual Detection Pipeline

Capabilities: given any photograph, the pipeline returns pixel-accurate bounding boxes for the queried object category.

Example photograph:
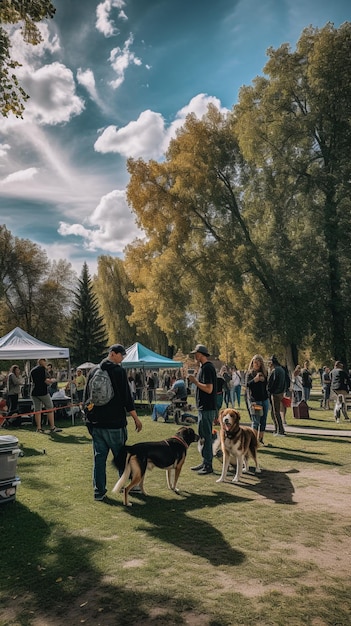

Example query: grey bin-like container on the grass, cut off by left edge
[0,435,21,504]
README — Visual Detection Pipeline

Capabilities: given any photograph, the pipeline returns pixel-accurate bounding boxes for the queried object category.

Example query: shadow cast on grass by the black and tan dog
[118,491,250,566]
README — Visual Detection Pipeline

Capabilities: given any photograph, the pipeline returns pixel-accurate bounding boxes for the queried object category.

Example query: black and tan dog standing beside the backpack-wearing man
[112,426,199,506]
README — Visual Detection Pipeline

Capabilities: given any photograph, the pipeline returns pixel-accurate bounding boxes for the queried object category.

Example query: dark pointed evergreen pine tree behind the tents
[68,263,107,366]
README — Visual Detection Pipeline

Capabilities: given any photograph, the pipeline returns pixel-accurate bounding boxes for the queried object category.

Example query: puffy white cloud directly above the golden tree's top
[94,94,228,159]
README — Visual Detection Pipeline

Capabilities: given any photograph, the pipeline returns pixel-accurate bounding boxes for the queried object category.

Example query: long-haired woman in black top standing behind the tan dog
[246,354,269,446]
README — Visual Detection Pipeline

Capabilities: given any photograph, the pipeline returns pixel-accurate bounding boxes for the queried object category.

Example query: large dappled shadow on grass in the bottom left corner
[0,502,212,626]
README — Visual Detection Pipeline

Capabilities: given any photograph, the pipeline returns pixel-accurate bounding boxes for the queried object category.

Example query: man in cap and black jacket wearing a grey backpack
[83,343,142,501]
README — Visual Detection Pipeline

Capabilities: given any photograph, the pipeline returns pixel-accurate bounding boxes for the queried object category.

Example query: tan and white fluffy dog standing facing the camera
[216,409,261,483]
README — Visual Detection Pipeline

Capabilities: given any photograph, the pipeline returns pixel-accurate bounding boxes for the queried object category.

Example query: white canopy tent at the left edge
[0,326,74,423]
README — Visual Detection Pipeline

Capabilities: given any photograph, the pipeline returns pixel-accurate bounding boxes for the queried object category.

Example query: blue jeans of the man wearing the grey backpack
[91,426,127,496]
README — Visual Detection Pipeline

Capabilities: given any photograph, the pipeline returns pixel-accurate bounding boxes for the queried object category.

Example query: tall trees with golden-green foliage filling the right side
[126,23,351,366]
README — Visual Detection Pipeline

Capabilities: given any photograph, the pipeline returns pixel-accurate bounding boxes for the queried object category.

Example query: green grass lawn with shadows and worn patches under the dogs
[0,400,351,626]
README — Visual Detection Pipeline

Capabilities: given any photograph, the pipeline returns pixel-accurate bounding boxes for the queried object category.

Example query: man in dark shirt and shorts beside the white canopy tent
[30,359,62,433]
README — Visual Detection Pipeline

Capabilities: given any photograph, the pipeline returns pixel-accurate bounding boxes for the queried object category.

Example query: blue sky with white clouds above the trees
[0,0,351,273]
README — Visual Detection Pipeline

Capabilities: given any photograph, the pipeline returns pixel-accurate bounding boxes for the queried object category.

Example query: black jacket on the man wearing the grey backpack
[83,359,135,429]
